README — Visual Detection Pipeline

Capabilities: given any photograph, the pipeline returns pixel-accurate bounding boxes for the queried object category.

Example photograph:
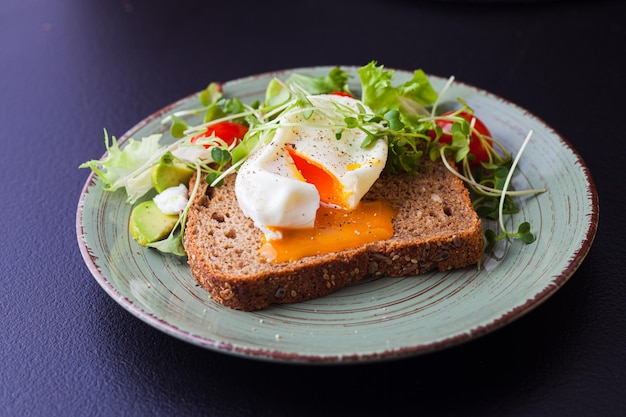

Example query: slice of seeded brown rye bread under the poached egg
[184,161,483,311]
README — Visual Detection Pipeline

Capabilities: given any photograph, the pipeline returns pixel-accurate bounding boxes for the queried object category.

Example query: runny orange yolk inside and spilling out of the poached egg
[260,147,396,263]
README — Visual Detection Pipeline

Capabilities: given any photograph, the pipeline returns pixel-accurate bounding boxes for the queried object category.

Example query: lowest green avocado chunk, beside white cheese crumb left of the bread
[129,200,178,246]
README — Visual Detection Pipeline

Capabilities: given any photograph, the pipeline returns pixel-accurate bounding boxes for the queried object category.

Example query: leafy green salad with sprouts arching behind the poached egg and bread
[80,61,545,256]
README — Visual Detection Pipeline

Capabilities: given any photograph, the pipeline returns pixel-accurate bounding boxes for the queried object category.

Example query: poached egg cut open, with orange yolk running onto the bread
[235,94,394,262]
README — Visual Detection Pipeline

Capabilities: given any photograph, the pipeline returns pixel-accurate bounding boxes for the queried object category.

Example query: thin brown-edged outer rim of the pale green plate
[76,65,599,364]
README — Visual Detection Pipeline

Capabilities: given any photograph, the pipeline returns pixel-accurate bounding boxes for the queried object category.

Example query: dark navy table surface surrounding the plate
[0,0,626,417]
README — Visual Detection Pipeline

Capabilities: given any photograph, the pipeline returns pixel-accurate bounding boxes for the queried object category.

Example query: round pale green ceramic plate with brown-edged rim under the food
[76,67,598,363]
